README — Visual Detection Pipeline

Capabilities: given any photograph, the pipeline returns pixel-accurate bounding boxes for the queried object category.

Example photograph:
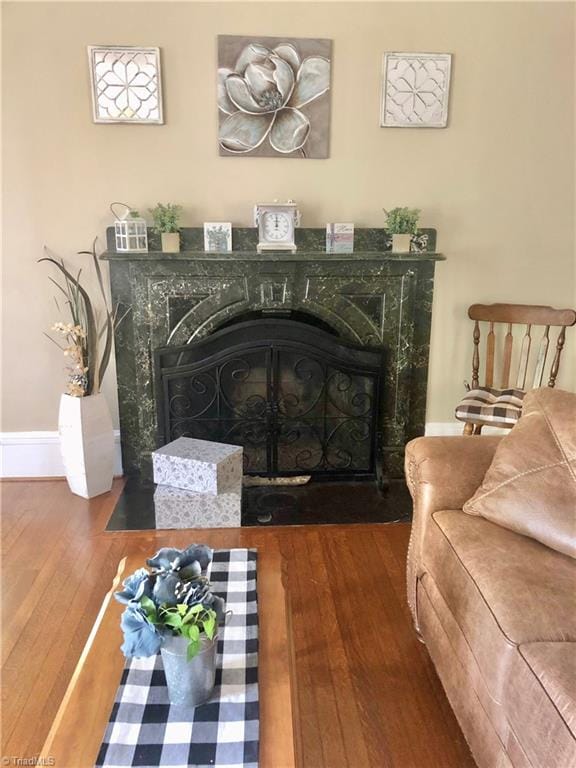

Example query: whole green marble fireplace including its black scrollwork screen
[103,228,443,478]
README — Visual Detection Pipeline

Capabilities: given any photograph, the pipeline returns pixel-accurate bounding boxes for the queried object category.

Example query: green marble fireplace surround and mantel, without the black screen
[102,227,444,478]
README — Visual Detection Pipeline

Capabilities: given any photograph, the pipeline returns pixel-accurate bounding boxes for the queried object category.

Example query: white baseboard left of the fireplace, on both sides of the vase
[0,430,122,477]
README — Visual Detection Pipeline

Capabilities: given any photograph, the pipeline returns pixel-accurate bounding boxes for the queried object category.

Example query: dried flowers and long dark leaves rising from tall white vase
[39,239,126,397]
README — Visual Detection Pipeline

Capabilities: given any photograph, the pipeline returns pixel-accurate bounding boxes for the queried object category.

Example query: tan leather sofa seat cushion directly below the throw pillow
[422,510,576,703]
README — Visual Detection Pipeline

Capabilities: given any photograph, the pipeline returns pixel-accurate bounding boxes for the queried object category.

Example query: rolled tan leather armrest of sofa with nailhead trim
[405,435,502,631]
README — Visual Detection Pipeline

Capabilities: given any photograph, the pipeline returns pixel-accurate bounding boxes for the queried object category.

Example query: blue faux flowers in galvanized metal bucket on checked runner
[114,544,225,707]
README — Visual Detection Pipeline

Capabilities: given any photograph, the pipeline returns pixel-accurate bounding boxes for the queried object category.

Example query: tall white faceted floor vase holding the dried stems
[58,393,114,499]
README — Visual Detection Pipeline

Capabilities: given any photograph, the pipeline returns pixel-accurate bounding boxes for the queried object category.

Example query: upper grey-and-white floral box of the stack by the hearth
[152,437,242,496]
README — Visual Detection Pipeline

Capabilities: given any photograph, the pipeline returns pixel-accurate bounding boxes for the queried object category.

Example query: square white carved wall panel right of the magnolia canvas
[380,53,452,128]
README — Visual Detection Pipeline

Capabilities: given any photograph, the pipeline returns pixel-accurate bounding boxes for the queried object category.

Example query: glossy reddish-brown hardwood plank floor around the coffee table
[1,480,474,768]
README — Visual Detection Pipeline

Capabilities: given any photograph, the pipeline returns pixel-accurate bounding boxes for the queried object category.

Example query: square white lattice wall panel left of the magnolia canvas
[88,45,164,125]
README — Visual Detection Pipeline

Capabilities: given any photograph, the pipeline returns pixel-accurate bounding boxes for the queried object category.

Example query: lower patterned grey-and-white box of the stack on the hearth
[154,485,242,528]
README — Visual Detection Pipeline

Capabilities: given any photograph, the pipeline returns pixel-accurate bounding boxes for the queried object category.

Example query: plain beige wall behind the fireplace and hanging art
[2,2,576,431]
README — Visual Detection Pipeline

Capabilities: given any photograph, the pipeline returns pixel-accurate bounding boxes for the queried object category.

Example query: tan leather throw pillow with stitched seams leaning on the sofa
[464,387,576,557]
